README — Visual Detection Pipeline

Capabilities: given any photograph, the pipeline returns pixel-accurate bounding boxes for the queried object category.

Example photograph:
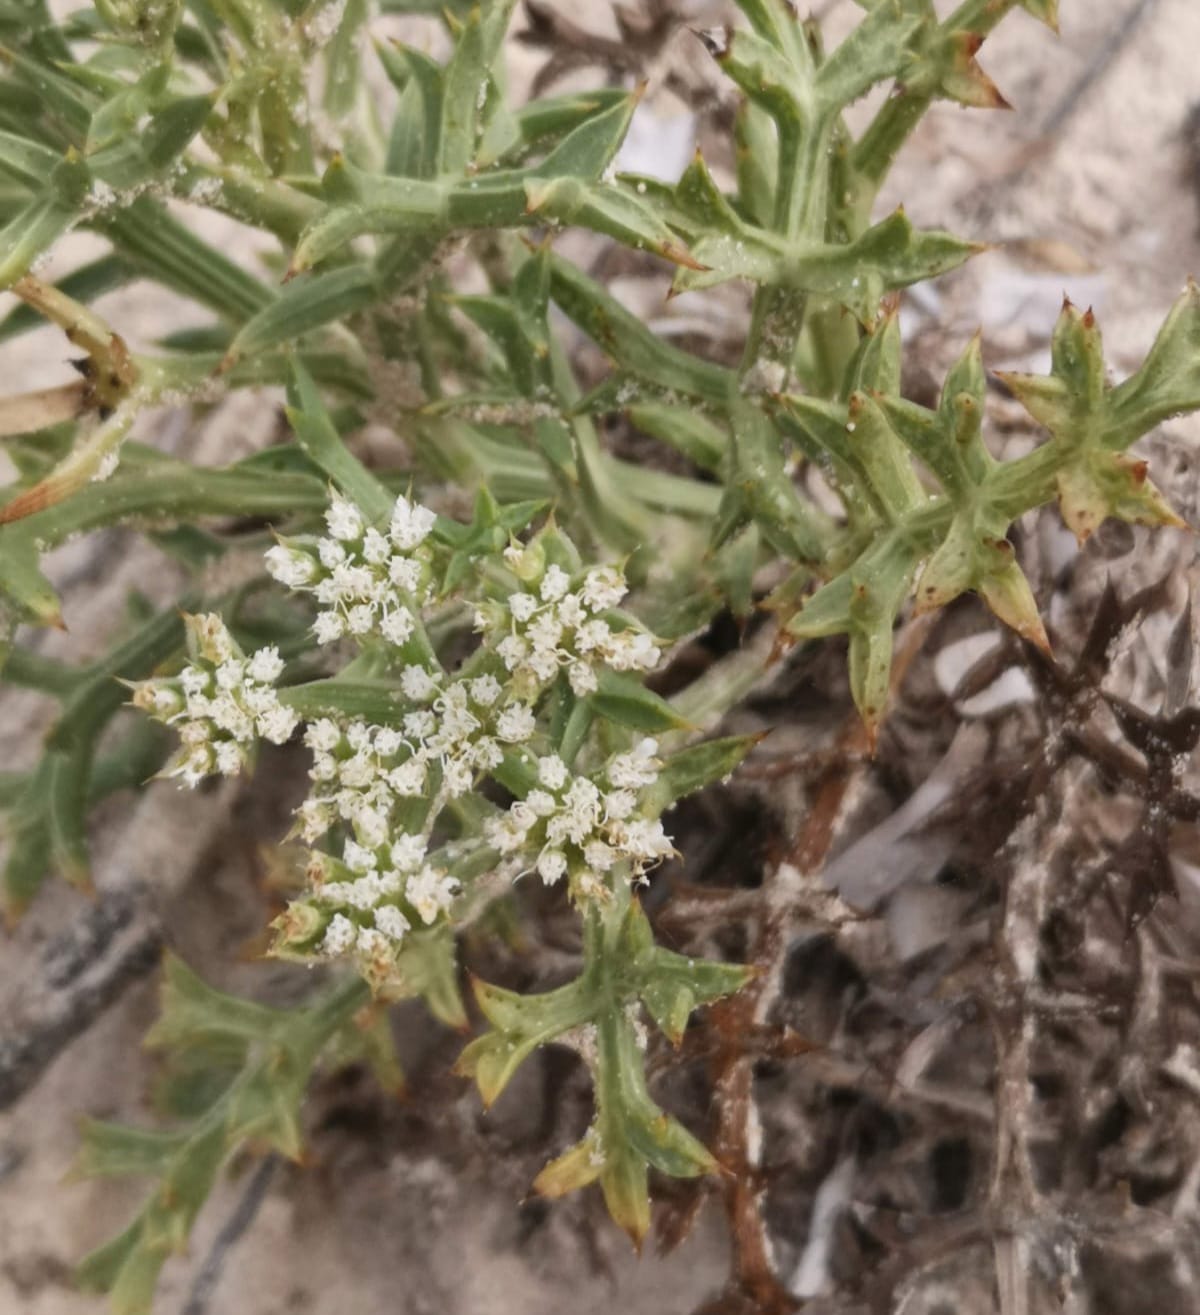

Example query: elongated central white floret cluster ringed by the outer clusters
[300,665,536,848]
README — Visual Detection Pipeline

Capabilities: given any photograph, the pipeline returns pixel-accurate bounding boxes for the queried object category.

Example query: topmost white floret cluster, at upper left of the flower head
[267,497,435,647]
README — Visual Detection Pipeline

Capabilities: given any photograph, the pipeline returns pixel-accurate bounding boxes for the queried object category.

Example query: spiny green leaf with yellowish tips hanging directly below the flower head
[457,899,748,1247]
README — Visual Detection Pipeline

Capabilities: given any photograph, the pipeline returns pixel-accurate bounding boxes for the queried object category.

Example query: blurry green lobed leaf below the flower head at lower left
[75,957,373,1315]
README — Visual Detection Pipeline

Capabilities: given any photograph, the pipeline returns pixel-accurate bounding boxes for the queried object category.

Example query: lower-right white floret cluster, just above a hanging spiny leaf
[486,739,674,898]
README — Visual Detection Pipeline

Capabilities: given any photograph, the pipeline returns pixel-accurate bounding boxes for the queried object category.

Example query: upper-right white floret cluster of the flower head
[476,546,661,698]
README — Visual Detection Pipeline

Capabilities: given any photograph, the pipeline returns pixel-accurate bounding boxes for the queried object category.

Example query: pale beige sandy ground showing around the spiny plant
[0,0,1200,1315]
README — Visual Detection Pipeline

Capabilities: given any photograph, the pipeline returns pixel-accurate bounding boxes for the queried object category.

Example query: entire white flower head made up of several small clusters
[134,497,672,990]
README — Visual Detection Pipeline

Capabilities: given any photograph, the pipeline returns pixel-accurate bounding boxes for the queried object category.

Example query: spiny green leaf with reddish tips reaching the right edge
[777,284,1200,729]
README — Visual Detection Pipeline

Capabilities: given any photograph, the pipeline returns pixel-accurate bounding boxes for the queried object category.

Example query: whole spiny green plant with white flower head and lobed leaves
[0,0,1200,1315]
